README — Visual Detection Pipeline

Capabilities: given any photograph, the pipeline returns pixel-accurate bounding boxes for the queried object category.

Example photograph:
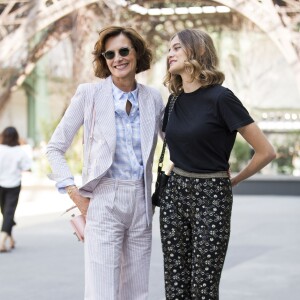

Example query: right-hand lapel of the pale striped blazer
[138,85,156,166]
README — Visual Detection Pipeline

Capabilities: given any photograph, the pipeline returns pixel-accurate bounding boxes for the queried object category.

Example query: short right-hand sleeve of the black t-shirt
[218,89,254,132]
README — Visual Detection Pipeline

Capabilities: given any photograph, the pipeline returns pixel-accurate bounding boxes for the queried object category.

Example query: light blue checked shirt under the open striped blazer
[106,84,144,180]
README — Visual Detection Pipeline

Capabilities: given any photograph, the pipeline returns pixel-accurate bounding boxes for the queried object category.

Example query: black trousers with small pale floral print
[160,172,232,300]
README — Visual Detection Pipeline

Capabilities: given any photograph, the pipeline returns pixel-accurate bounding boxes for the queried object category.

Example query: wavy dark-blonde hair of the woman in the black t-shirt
[164,29,225,95]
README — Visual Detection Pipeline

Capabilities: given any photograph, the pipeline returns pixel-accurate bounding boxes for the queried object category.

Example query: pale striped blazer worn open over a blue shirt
[46,77,164,224]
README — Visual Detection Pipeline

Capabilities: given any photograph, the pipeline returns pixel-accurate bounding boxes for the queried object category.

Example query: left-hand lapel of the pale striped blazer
[94,77,116,155]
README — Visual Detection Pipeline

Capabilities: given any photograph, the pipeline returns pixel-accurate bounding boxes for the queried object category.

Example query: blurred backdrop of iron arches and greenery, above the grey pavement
[0,0,300,176]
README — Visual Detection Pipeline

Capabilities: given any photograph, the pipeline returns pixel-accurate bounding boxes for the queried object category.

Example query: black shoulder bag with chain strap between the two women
[151,95,178,206]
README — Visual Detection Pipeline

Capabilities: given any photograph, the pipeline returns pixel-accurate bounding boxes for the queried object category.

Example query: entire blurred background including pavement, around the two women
[0,0,300,300]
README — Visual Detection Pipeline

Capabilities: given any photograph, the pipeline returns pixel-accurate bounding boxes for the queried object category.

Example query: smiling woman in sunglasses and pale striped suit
[47,26,164,300]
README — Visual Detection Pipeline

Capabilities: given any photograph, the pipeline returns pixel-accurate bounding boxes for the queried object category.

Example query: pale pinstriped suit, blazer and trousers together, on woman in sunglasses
[46,77,164,300]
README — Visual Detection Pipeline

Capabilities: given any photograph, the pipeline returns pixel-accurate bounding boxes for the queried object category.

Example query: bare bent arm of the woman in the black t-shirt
[231,123,276,186]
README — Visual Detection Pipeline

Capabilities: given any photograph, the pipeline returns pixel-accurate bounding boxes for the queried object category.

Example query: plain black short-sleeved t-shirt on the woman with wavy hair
[166,85,254,173]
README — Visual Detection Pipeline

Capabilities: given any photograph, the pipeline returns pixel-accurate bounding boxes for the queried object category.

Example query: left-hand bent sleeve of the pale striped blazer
[46,85,85,183]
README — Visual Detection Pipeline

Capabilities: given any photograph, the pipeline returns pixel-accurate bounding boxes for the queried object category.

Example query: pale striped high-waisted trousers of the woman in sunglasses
[84,178,152,300]
